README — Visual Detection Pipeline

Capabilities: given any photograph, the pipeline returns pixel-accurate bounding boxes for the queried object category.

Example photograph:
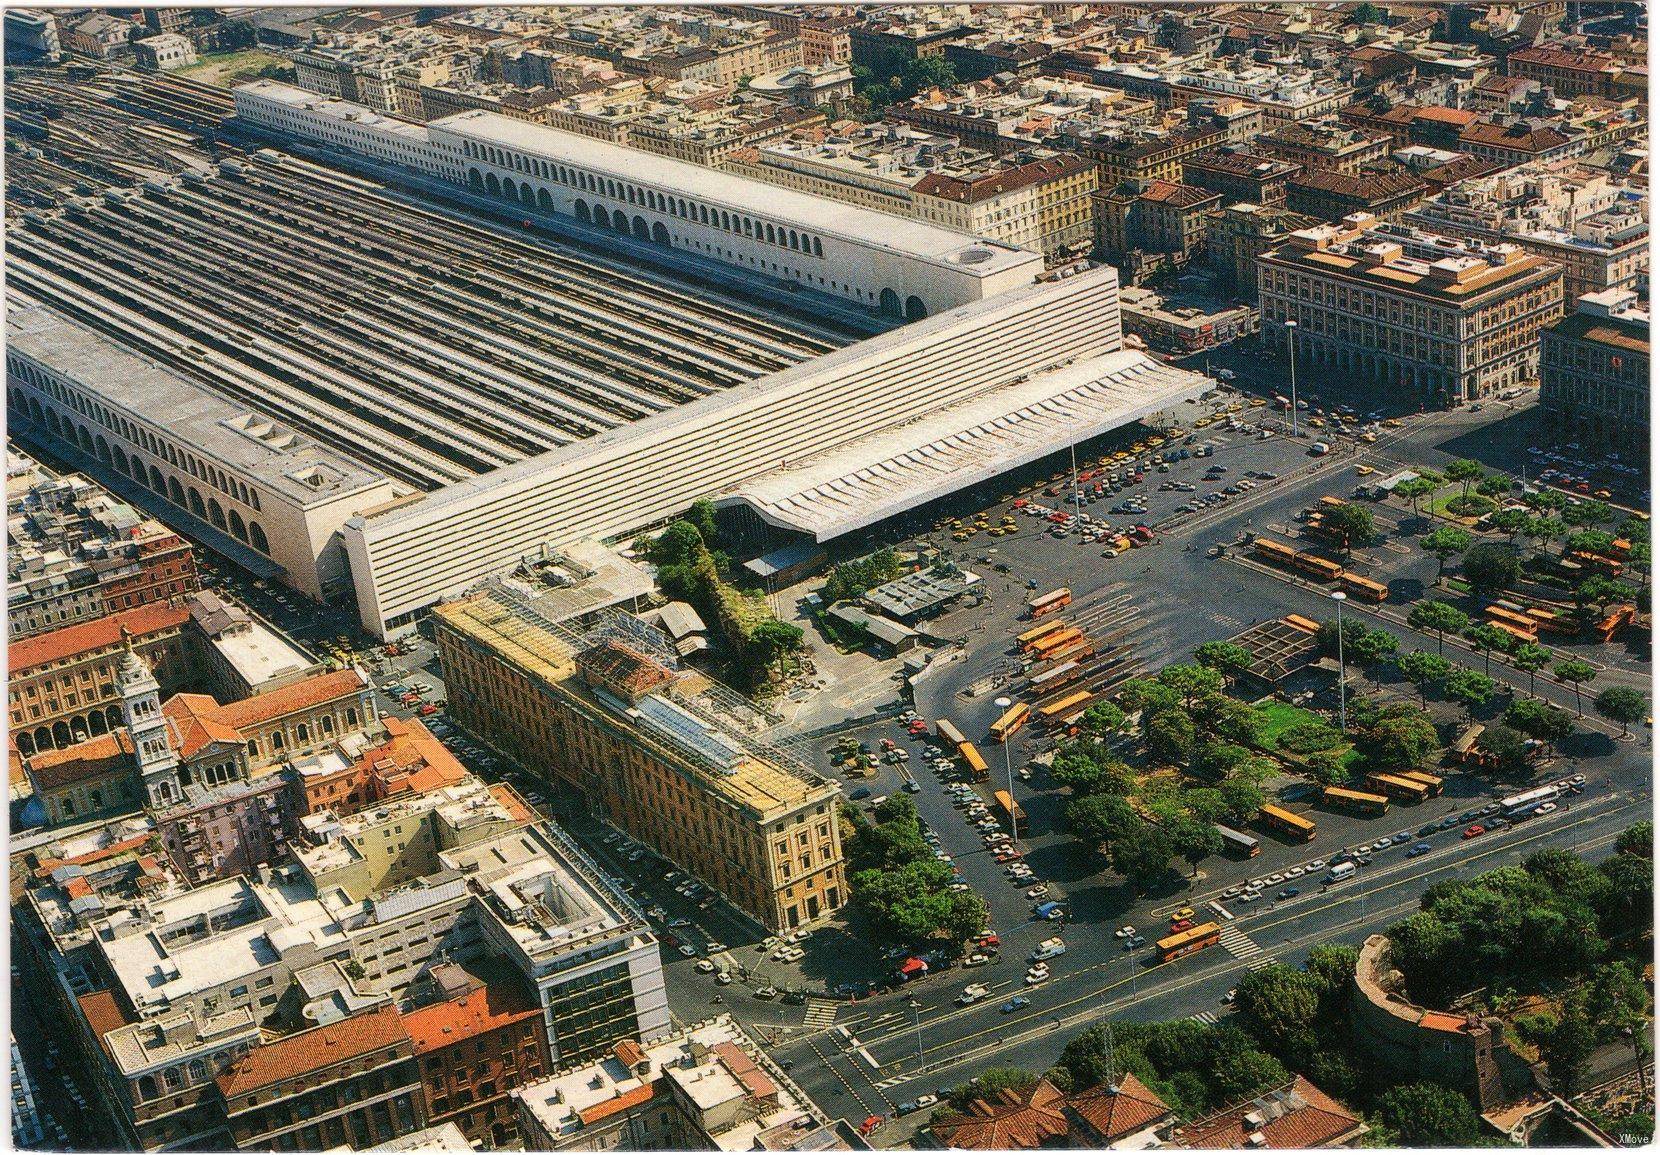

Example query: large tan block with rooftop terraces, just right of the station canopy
[1257,214,1562,403]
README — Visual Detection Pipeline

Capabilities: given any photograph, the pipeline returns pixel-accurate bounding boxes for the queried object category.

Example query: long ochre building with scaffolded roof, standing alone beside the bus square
[433,584,847,929]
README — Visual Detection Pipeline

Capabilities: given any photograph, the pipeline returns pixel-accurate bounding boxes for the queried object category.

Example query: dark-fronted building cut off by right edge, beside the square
[1539,289,1650,456]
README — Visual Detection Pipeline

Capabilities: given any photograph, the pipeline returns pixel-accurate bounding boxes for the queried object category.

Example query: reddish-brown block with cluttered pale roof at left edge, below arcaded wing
[7,470,201,642]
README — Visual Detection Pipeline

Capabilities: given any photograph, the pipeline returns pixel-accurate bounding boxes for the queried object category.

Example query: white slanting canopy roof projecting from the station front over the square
[715,350,1213,541]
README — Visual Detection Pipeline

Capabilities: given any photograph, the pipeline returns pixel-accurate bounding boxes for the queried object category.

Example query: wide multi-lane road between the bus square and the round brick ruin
[774,788,1652,1145]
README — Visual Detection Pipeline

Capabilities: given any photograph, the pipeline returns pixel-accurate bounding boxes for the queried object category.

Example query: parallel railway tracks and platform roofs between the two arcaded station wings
[7,70,855,490]
